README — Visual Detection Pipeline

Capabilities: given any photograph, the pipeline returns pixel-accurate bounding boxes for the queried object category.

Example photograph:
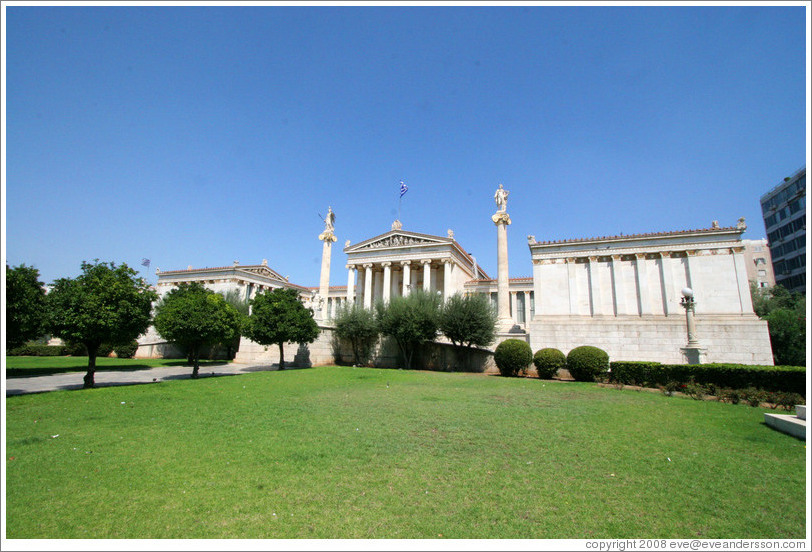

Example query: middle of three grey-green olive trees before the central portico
[375,289,440,370]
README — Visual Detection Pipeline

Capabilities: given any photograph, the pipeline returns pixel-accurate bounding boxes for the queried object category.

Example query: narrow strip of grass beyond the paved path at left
[6,356,229,378]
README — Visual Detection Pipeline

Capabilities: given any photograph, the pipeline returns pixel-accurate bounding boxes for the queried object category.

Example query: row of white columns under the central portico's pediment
[347,259,454,309]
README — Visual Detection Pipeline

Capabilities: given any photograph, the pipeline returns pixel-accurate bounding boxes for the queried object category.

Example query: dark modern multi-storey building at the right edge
[761,167,806,293]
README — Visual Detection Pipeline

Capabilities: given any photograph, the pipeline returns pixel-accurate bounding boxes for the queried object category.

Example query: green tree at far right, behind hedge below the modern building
[750,282,806,366]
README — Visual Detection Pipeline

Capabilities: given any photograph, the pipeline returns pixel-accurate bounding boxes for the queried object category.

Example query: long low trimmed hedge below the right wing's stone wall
[609,361,806,397]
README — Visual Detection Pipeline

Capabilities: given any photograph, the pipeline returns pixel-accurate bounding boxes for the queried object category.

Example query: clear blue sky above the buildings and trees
[3,3,809,286]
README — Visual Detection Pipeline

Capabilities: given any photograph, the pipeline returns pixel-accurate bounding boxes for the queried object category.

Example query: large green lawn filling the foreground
[6,367,806,539]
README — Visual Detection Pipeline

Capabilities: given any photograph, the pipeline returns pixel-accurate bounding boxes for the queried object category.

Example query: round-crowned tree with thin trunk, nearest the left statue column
[244,288,319,370]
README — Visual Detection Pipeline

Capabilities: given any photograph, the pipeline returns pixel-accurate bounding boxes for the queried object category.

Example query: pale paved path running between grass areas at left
[6,362,279,397]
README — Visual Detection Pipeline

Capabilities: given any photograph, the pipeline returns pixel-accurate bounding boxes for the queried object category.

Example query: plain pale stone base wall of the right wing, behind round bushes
[529,315,773,365]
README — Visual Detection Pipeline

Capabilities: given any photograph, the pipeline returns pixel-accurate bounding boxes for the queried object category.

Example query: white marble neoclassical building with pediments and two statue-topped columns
[138,186,773,365]
